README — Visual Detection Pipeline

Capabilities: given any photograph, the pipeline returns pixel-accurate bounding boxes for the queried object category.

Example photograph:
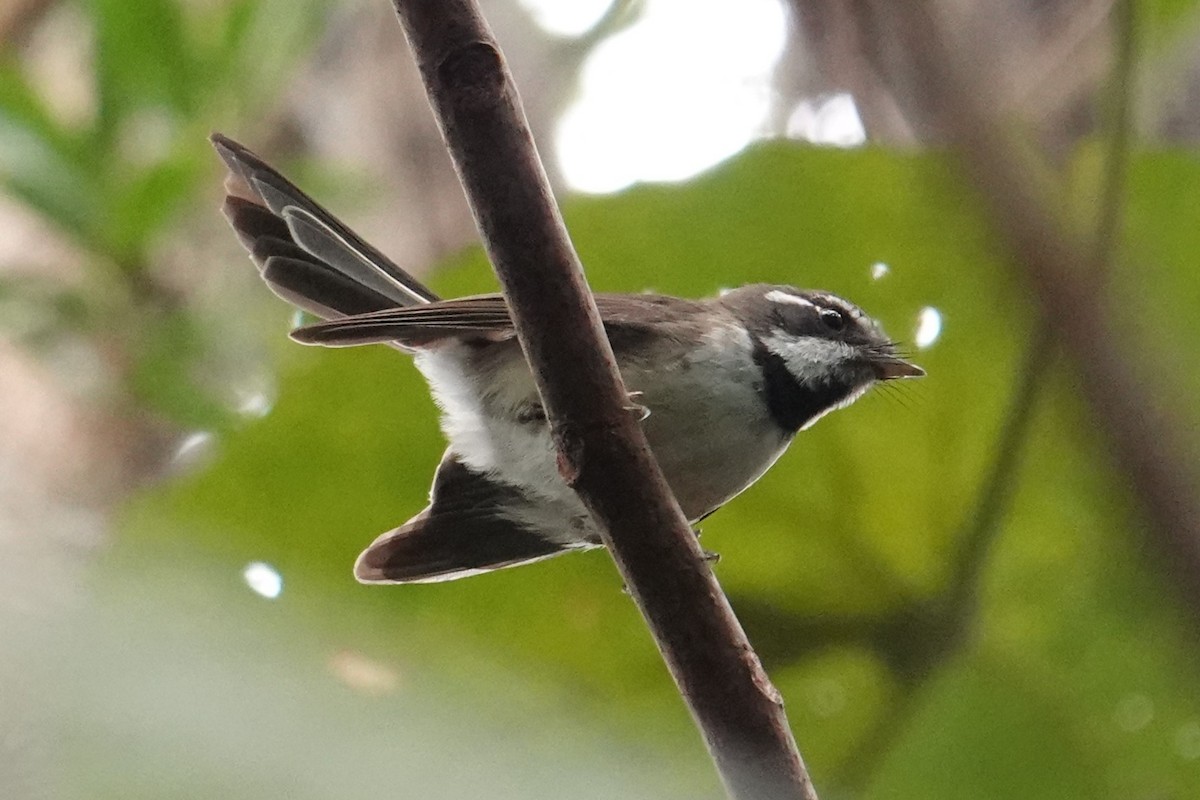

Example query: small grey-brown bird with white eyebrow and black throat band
[211,133,925,584]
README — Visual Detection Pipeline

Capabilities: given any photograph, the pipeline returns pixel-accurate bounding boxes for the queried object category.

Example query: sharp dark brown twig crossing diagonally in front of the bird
[395,0,816,800]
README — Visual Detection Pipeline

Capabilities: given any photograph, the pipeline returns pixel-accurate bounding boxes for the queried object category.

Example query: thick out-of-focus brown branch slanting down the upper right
[866,0,1200,616]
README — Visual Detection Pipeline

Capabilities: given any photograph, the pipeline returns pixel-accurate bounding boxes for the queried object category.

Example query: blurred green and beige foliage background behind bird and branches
[0,0,1200,800]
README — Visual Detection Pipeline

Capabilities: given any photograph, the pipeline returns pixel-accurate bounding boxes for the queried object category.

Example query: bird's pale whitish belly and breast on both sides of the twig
[418,331,791,532]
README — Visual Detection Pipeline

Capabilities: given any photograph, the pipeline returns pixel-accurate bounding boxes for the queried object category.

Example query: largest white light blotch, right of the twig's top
[556,0,786,193]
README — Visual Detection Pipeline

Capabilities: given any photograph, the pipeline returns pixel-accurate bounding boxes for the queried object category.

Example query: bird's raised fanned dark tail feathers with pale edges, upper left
[211,133,438,319]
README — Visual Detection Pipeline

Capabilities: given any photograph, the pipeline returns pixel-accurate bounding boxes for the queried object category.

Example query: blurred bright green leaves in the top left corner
[0,0,325,262]
